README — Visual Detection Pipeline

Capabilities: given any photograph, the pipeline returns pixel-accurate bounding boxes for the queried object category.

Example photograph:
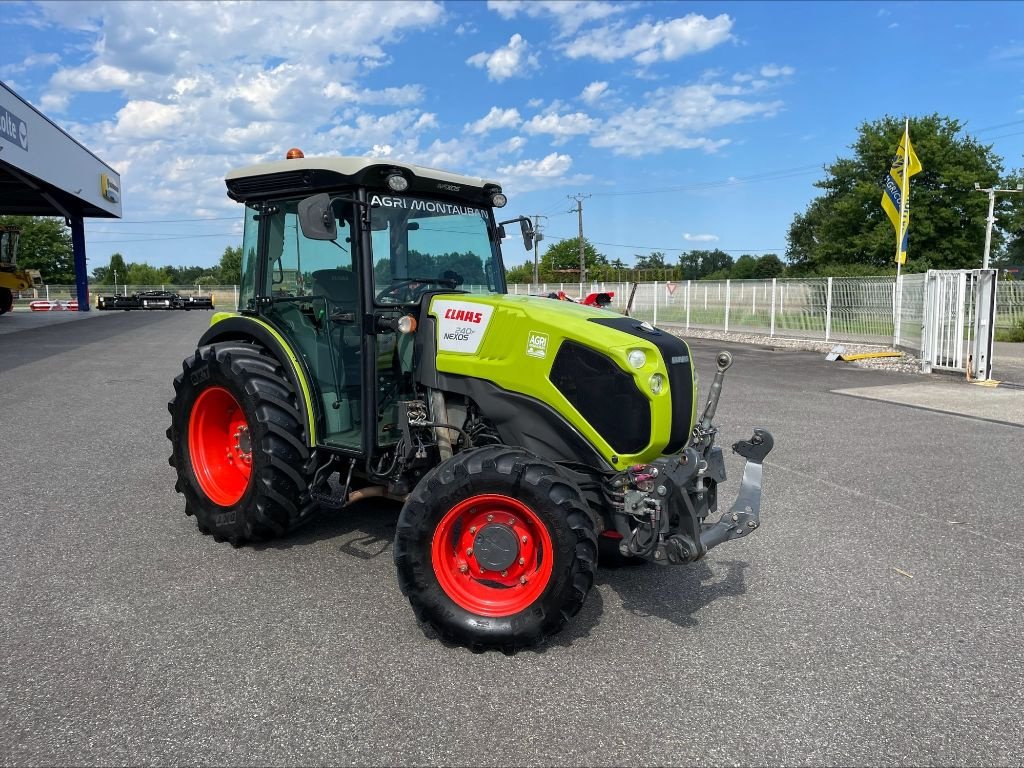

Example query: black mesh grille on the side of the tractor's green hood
[549,341,650,454]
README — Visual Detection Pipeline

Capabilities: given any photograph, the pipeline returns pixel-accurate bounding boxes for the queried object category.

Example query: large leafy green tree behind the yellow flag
[786,115,1002,274]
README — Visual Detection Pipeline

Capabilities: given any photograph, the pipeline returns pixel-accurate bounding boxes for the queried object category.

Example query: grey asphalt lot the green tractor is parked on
[0,312,1024,765]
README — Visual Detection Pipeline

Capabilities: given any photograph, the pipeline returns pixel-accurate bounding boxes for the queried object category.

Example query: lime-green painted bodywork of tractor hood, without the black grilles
[429,294,696,468]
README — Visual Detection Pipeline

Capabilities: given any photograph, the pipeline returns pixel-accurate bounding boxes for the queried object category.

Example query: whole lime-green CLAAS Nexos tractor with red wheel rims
[167,151,772,652]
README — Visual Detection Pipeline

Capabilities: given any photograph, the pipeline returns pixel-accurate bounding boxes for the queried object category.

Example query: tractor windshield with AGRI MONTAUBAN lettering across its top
[370,195,505,304]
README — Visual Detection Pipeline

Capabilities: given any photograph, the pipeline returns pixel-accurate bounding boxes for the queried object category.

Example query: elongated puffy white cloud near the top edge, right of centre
[563,13,732,67]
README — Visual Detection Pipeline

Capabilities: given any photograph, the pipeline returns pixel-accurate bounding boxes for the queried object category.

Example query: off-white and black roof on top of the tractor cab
[224,157,501,200]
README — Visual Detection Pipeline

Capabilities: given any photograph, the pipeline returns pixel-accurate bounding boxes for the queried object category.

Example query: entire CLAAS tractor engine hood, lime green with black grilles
[421,294,696,468]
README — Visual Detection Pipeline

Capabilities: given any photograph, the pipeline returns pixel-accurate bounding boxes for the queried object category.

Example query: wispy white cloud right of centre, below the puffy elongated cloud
[591,83,782,157]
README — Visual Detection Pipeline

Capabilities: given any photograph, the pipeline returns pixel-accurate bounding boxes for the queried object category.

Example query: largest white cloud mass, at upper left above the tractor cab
[18,0,445,227]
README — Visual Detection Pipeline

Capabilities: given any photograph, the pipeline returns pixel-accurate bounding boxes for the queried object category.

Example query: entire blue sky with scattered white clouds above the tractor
[0,1,1024,268]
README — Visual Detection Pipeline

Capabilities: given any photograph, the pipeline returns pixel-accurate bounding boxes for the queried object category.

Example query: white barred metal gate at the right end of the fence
[921,269,996,381]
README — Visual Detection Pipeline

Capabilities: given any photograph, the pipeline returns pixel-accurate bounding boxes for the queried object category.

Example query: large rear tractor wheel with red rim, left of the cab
[167,342,316,546]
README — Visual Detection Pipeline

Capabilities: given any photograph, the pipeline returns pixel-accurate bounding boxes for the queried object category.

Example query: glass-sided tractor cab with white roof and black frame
[220,157,532,456]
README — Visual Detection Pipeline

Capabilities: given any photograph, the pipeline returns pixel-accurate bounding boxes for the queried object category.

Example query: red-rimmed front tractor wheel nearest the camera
[394,445,597,652]
